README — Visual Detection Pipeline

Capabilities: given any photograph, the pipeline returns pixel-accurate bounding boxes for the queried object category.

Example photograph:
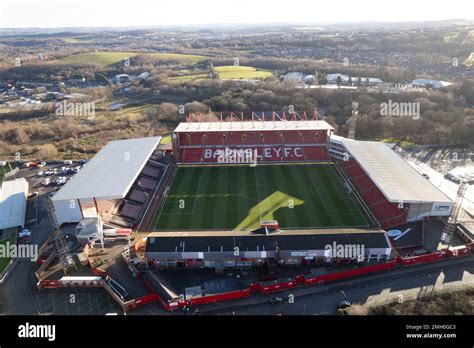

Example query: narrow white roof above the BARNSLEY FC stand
[174,121,334,133]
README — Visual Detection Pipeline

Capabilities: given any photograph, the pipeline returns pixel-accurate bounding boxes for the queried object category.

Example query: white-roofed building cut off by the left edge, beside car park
[0,178,28,229]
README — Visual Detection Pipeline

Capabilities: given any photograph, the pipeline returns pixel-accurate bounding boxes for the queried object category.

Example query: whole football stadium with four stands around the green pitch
[53,112,453,270]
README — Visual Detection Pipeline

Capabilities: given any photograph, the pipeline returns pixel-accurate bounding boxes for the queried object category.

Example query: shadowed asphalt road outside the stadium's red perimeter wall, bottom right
[199,256,474,315]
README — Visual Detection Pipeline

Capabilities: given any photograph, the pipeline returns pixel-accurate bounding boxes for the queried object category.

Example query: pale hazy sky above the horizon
[0,0,474,28]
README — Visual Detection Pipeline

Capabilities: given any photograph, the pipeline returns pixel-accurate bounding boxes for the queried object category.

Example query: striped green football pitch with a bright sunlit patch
[151,163,372,231]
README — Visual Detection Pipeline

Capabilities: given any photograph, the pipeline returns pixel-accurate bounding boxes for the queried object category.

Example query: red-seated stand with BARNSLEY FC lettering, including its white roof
[173,120,333,164]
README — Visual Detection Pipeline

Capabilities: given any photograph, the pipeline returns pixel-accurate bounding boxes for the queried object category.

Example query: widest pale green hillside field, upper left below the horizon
[51,51,206,66]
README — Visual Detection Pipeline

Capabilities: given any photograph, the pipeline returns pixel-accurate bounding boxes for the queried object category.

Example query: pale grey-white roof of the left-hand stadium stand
[52,137,161,201]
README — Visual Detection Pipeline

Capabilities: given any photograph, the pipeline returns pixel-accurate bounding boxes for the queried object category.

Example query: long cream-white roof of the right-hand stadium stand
[337,137,452,203]
